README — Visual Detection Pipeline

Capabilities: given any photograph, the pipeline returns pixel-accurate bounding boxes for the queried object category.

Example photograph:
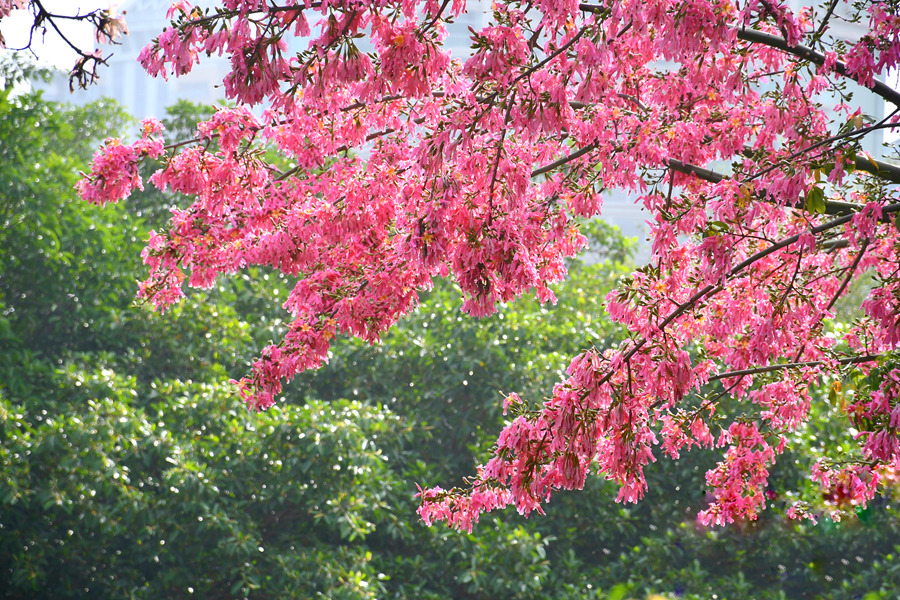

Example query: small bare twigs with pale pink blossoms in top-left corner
[0,0,128,89]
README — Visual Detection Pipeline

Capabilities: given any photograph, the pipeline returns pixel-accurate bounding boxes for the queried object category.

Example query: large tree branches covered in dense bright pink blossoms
[68,0,900,529]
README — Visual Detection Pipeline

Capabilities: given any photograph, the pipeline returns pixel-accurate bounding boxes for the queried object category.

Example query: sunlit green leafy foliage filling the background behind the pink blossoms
[0,85,900,600]
